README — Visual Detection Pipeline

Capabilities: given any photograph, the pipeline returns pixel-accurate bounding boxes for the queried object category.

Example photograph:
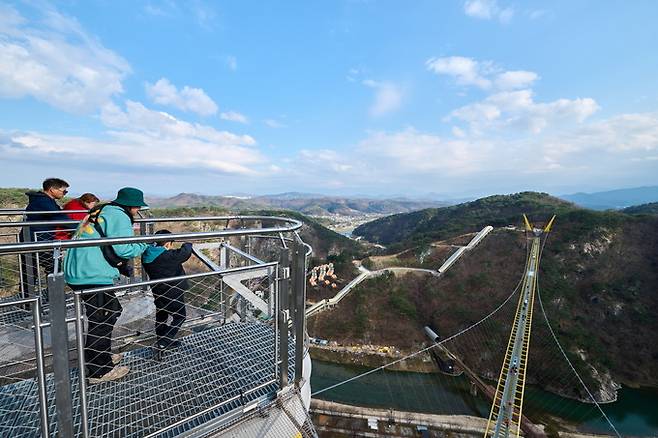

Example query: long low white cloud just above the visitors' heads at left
[3,101,268,176]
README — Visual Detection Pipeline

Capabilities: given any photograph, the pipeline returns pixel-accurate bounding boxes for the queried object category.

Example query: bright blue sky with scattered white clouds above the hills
[0,0,658,197]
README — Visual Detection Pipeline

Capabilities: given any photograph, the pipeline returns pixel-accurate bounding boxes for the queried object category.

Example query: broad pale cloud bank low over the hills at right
[288,113,658,193]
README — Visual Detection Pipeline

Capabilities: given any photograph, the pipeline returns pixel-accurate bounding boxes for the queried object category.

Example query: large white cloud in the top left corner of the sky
[0,5,130,113]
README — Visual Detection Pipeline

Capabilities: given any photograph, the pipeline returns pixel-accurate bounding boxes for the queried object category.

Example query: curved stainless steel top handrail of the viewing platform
[0,216,302,254]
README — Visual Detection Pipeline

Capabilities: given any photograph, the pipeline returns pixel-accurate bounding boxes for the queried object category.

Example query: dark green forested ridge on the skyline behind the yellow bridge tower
[353,192,579,249]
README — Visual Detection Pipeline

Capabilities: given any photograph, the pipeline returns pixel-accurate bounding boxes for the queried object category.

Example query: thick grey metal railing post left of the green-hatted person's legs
[48,273,73,438]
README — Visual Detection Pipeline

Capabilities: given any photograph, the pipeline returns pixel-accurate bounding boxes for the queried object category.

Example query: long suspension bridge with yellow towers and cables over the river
[312,215,621,438]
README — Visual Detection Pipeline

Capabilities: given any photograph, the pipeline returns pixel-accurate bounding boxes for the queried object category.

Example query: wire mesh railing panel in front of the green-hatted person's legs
[65,266,292,436]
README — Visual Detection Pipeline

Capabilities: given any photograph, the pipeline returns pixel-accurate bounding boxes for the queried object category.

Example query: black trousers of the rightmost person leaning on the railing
[153,285,186,348]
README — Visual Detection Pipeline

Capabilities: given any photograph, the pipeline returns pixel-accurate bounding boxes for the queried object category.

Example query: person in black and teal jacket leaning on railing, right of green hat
[142,230,192,360]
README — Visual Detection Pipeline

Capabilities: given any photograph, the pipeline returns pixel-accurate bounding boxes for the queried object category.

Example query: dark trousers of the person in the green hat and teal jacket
[69,284,123,377]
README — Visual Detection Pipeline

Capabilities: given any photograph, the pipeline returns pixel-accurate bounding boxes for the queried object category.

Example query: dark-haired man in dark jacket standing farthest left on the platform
[25,178,70,277]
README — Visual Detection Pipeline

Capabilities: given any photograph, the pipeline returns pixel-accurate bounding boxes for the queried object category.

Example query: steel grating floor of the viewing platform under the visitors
[0,323,294,437]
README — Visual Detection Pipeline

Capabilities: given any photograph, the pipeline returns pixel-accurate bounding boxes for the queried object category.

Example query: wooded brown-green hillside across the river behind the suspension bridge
[309,193,658,396]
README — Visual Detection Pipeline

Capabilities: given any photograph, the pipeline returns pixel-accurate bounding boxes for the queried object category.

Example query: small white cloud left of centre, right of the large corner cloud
[146,78,218,116]
